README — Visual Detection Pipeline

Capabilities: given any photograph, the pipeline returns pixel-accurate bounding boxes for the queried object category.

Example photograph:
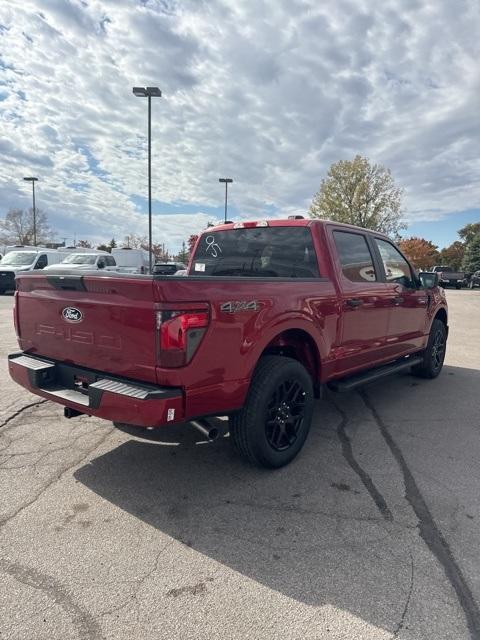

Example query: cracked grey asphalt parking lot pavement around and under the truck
[0,290,480,640]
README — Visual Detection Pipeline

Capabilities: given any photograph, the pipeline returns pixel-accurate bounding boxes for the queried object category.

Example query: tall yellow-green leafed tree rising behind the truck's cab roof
[309,155,405,236]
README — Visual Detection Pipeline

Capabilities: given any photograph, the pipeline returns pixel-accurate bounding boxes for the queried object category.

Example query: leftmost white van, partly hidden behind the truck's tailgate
[0,247,65,294]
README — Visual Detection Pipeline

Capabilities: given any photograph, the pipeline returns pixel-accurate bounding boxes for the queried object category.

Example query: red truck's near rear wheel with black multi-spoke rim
[229,356,314,469]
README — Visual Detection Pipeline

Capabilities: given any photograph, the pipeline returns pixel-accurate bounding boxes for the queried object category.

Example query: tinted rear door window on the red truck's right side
[333,231,378,283]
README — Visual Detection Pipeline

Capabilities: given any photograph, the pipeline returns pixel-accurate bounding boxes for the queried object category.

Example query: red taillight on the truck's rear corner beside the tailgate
[157,309,209,367]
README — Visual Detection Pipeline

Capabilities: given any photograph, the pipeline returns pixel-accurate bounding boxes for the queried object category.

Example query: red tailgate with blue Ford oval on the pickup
[15,273,156,382]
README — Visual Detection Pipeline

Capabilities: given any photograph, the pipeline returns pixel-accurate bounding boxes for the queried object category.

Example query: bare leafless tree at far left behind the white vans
[0,208,55,245]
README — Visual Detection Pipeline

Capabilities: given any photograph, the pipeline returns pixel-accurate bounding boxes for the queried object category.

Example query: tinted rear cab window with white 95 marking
[190,227,320,278]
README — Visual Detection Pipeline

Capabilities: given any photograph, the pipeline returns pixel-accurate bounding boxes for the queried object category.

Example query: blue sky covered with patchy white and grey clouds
[0,0,480,250]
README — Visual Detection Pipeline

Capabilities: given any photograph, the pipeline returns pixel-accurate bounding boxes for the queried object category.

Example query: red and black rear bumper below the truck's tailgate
[8,352,184,427]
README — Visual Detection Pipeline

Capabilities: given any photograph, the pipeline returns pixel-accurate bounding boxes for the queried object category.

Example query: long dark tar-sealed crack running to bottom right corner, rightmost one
[360,391,480,640]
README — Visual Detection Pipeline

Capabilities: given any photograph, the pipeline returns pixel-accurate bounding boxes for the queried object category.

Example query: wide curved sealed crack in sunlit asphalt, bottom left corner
[0,558,104,640]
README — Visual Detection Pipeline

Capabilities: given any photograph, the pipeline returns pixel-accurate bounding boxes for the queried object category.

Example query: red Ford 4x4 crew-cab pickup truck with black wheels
[9,219,448,467]
